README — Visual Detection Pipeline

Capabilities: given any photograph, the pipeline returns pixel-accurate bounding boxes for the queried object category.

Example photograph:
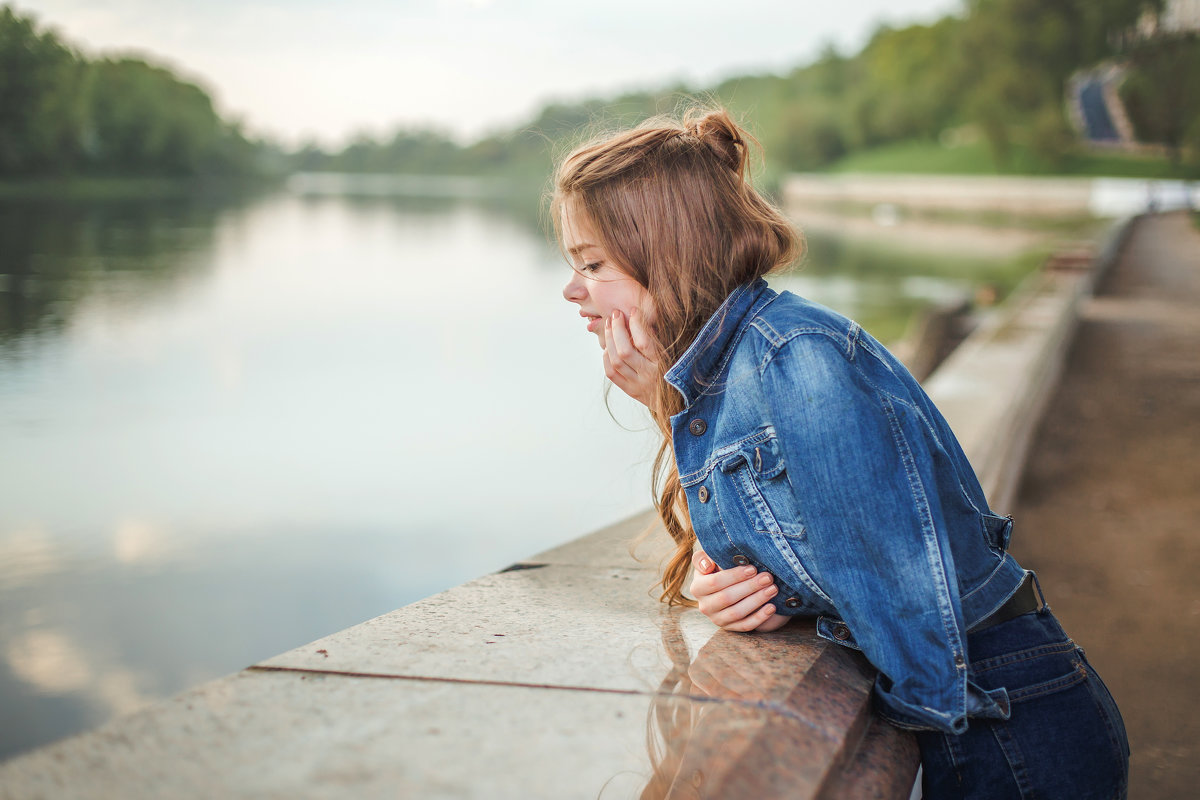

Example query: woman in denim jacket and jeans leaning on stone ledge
[552,110,1128,799]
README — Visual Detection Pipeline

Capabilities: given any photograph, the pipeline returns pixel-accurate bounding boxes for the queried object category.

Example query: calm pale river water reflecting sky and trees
[0,183,1032,758]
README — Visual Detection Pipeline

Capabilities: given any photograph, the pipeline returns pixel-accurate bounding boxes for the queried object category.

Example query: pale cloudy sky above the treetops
[13,0,961,146]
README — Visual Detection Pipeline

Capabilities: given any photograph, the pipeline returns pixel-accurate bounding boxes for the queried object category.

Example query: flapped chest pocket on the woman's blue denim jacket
[718,438,804,536]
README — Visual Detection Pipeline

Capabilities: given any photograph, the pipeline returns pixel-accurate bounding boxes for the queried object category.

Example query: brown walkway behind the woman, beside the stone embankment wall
[1013,213,1200,798]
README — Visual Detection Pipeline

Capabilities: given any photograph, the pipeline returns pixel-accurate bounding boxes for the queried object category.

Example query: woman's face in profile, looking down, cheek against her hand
[562,203,654,348]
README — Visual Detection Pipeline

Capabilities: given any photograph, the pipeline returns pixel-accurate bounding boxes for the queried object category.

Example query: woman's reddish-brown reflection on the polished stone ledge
[633,612,918,800]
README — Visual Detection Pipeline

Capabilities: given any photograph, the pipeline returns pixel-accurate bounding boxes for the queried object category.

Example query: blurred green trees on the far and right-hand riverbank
[296,0,1200,175]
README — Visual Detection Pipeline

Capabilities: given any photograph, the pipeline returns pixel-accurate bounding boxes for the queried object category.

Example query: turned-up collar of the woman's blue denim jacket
[665,278,775,407]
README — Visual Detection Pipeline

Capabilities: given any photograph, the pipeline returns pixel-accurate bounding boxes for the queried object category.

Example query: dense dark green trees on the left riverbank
[0,6,263,178]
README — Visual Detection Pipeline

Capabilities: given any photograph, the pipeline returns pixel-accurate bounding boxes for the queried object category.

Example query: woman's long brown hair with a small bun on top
[551,109,803,606]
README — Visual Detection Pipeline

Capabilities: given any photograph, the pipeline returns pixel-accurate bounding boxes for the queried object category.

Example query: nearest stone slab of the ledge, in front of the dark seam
[0,672,914,800]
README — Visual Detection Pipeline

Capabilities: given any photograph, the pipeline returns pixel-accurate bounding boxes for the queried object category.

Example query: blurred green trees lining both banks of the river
[0,0,1200,180]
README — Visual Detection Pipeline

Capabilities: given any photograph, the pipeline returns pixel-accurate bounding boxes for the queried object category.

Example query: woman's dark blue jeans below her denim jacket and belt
[917,608,1129,800]
